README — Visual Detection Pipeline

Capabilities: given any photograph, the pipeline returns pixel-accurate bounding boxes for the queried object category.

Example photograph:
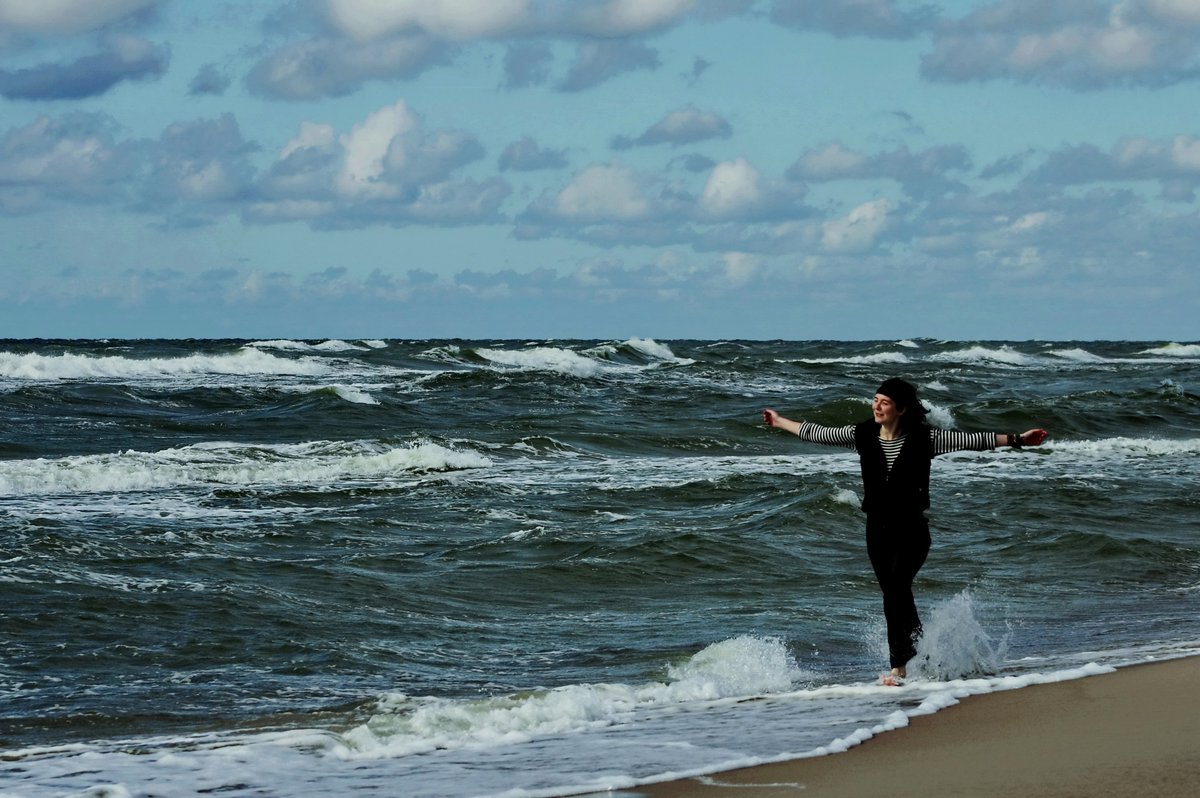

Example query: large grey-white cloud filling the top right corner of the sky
[920,0,1200,90]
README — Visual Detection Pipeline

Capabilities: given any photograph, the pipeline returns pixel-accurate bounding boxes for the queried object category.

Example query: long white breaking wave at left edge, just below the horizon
[0,347,328,382]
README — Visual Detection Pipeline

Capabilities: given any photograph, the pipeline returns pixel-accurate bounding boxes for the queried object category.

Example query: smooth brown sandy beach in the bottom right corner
[616,656,1200,798]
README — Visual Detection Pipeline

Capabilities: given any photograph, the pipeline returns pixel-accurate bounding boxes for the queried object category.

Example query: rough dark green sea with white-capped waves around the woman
[0,337,1200,798]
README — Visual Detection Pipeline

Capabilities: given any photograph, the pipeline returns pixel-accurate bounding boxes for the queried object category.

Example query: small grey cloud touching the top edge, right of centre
[770,0,937,38]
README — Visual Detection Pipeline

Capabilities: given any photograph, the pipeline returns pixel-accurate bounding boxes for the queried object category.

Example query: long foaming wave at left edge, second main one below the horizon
[0,442,491,496]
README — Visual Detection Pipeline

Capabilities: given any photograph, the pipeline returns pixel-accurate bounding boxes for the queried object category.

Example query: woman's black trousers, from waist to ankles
[866,514,930,667]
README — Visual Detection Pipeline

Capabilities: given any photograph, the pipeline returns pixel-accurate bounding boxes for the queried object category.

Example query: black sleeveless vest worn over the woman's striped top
[854,420,934,516]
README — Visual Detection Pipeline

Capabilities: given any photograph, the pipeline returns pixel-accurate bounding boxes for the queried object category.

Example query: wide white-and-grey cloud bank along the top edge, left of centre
[247,0,751,100]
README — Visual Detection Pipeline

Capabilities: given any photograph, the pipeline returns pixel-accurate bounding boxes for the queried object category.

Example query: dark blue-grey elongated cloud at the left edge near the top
[0,36,170,101]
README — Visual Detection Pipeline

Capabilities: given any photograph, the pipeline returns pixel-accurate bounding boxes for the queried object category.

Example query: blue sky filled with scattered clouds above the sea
[0,0,1200,342]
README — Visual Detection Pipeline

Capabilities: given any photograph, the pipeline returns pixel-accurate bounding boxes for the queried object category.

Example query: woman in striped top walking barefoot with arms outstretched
[762,378,1046,684]
